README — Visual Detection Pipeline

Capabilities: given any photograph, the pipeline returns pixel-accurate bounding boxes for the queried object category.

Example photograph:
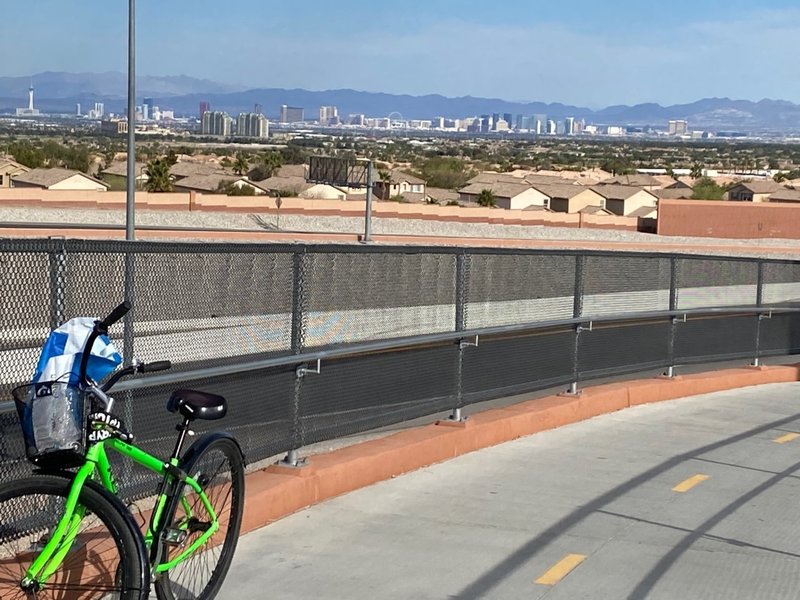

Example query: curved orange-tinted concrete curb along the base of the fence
[242,364,800,533]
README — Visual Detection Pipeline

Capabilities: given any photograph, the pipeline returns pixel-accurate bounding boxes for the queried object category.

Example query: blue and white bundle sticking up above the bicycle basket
[33,317,122,385]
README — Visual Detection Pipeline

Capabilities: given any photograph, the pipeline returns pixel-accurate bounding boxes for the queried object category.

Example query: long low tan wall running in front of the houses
[0,188,638,231]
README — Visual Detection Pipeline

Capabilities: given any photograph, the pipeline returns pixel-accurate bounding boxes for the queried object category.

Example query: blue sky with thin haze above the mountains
[0,0,800,109]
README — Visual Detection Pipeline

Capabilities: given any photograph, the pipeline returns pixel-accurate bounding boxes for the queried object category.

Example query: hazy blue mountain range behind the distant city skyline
[0,72,800,132]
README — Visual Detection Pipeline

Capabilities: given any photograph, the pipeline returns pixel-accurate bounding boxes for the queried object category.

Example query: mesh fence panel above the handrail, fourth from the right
[465,254,575,329]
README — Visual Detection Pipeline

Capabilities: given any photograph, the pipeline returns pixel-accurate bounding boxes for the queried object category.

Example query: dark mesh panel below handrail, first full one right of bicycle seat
[300,344,458,444]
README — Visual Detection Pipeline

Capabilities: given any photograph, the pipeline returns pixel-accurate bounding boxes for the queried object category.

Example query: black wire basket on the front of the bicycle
[12,381,87,470]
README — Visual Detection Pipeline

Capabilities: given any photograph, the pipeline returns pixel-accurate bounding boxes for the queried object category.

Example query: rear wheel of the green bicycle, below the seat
[155,433,244,600]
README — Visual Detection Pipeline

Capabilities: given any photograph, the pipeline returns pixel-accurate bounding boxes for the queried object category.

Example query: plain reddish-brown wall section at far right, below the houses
[658,200,800,239]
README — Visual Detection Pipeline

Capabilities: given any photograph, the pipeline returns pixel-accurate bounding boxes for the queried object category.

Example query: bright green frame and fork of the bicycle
[22,438,219,585]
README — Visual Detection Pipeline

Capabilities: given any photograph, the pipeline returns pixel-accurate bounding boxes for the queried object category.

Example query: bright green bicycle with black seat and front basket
[0,302,244,600]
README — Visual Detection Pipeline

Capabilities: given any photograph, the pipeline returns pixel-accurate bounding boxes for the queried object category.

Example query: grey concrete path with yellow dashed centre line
[218,383,800,600]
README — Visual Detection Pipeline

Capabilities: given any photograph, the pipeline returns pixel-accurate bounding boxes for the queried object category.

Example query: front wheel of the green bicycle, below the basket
[0,475,150,600]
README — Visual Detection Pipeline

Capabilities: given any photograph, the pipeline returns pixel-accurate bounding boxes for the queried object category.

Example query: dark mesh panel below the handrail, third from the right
[578,322,672,381]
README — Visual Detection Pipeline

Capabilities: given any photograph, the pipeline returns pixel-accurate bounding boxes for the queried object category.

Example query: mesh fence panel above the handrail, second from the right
[677,258,758,310]
